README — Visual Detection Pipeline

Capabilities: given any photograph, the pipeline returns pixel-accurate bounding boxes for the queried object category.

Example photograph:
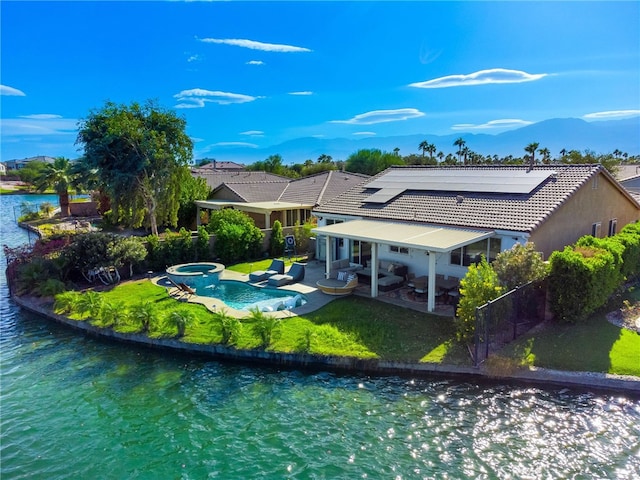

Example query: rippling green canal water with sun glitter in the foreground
[0,196,640,480]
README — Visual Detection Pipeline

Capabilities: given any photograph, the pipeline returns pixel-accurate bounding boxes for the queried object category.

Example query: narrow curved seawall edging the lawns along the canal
[11,295,640,398]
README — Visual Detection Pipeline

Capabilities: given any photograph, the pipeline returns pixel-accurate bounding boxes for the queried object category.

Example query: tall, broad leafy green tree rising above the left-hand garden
[76,101,193,235]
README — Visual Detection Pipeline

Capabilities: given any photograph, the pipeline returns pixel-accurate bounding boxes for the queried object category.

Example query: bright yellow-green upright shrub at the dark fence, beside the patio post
[455,255,504,342]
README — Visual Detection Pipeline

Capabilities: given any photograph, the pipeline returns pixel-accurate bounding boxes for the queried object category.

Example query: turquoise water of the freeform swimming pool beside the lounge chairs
[196,277,307,312]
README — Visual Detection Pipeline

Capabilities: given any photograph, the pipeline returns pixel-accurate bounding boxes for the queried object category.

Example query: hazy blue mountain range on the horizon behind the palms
[207,116,640,164]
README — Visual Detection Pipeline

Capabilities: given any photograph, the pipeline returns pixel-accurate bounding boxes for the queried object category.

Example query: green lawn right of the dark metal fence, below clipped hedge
[499,288,640,376]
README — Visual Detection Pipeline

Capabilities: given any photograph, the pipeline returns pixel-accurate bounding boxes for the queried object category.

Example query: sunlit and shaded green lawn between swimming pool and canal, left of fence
[65,280,470,365]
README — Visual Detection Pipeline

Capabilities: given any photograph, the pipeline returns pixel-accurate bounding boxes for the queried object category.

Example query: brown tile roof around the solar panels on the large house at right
[314,165,640,232]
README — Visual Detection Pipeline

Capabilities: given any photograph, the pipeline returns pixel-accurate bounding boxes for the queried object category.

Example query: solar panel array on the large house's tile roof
[365,169,556,203]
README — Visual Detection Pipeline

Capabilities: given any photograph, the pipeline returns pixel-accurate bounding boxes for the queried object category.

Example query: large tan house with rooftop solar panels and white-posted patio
[313,165,640,311]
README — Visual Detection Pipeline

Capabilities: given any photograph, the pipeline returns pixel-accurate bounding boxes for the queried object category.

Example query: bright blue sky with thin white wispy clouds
[0,1,640,160]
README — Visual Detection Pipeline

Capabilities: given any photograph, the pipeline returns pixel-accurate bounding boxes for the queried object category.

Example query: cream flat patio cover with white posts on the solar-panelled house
[313,220,494,312]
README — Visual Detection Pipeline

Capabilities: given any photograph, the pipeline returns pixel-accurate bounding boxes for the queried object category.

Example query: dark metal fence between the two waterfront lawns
[472,282,546,366]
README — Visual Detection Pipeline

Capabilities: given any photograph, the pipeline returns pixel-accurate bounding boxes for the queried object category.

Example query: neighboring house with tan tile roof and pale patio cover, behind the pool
[196,170,370,228]
